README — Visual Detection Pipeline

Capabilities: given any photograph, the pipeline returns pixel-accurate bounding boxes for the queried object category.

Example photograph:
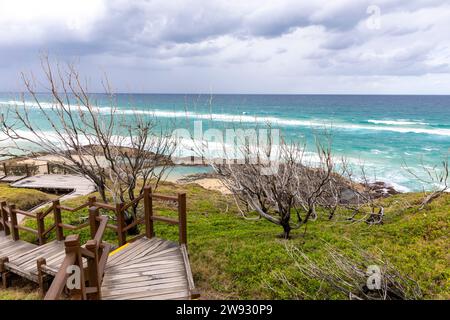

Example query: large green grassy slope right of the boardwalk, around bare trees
[0,184,450,299]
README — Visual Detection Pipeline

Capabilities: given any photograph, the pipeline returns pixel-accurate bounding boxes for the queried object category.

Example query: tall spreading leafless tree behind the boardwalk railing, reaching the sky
[1,57,175,218]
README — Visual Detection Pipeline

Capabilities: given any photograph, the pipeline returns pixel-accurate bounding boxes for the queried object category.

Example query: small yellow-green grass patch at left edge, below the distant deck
[0,183,54,210]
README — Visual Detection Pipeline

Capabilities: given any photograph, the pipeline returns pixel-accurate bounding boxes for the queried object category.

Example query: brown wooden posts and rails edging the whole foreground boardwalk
[0,186,190,300]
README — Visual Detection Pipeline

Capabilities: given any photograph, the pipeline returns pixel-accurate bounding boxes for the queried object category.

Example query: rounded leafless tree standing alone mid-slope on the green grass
[213,134,342,239]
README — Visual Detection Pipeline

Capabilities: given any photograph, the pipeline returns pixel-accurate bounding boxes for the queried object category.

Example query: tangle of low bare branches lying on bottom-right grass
[269,241,422,300]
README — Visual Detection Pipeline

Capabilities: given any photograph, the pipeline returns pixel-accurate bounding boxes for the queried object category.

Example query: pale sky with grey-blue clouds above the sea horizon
[0,0,450,94]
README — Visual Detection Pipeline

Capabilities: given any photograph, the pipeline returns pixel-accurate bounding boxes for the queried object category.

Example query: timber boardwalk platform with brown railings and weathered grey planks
[0,187,199,300]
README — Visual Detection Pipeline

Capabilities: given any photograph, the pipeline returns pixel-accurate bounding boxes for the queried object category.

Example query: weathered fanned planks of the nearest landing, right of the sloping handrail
[102,237,190,300]
